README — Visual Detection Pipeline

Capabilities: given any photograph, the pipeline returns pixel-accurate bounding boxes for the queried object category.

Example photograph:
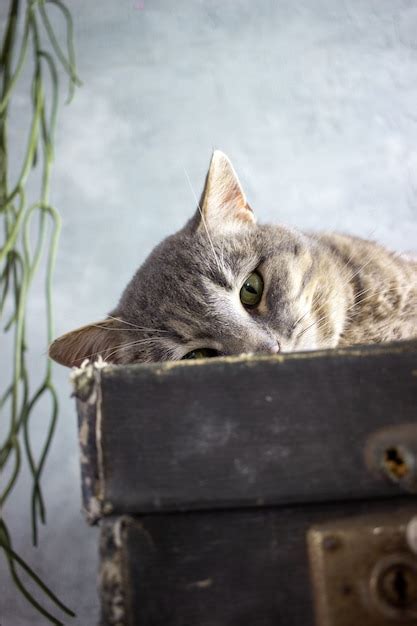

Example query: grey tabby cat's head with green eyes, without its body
[49,151,342,366]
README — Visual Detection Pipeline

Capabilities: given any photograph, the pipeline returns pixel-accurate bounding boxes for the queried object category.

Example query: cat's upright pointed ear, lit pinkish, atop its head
[200,150,256,230]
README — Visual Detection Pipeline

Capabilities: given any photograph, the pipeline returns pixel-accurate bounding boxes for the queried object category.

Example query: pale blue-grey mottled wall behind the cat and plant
[0,0,417,626]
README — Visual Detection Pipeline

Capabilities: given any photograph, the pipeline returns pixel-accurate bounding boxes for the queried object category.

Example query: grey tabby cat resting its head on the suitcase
[49,150,417,366]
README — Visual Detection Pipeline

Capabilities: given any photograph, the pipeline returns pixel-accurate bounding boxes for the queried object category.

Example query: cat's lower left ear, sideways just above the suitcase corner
[49,318,123,367]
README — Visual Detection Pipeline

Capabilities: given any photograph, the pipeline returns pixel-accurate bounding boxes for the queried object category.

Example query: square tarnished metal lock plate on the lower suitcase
[307,507,417,626]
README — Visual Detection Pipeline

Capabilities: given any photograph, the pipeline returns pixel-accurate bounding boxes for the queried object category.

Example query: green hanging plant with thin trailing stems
[0,0,80,624]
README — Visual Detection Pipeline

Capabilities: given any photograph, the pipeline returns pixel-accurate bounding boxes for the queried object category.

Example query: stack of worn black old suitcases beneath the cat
[73,341,417,626]
